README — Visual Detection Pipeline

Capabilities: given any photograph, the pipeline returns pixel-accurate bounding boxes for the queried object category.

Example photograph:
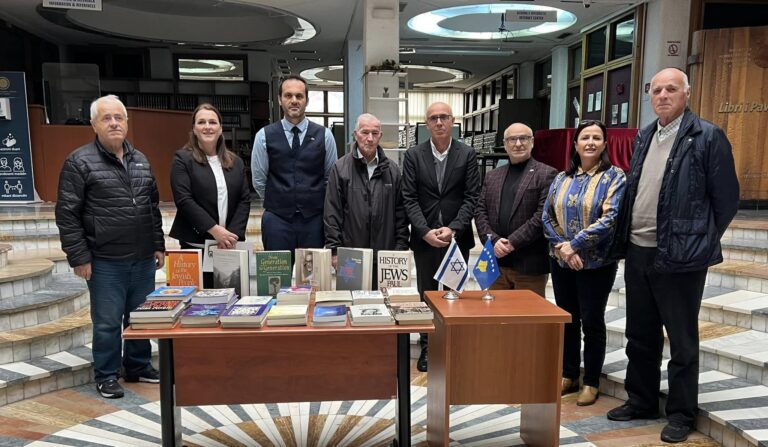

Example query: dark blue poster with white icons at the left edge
[0,71,35,203]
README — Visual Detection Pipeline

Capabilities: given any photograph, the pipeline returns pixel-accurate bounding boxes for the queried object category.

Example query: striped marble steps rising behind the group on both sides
[0,205,768,447]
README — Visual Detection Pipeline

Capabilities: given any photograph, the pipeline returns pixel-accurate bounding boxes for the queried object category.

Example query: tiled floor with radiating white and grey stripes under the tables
[0,364,719,447]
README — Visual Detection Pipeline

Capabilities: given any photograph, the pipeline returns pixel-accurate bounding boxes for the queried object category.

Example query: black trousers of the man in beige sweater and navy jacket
[624,244,707,427]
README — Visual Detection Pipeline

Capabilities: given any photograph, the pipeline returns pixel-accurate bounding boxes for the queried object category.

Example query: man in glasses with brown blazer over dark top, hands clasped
[475,123,557,296]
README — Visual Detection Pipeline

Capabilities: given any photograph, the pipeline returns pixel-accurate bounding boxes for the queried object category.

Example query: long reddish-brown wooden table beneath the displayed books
[123,313,434,447]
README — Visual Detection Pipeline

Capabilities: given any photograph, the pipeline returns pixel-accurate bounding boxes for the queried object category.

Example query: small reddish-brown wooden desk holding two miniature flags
[425,290,571,446]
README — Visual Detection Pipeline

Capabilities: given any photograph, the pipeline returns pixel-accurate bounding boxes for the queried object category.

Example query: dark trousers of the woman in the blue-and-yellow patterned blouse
[551,259,617,388]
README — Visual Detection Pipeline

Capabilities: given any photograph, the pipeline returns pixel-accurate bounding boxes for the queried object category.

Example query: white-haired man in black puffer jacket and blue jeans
[56,95,165,398]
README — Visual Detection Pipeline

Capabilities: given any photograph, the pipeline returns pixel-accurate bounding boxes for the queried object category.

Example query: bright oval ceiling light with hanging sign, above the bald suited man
[408,3,576,40]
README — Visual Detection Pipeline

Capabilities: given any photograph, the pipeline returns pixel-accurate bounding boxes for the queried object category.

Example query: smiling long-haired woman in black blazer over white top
[170,104,251,287]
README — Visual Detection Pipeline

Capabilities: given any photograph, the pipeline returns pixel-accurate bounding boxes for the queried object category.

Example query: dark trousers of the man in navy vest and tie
[261,210,325,262]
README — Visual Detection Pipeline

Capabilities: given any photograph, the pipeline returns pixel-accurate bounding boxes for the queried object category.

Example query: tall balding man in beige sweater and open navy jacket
[608,68,739,442]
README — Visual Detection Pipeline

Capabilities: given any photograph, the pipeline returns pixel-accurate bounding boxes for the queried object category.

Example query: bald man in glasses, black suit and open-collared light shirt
[403,102,480,372]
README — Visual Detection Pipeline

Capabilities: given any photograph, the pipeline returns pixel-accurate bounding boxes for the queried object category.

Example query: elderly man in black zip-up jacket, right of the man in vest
[323,113,408,284]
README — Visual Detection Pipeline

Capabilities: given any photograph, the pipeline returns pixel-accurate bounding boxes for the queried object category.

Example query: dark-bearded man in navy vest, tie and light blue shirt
[251,75,336,256]
